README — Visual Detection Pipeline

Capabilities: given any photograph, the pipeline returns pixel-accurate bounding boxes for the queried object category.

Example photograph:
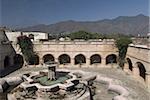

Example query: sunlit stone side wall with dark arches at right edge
[124,44,150,91]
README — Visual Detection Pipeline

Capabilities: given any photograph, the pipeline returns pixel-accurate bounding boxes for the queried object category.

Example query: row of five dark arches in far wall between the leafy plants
[42,54,117,65]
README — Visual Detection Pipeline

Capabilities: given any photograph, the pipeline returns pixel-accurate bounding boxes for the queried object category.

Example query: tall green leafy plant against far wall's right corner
[116,37,132,68]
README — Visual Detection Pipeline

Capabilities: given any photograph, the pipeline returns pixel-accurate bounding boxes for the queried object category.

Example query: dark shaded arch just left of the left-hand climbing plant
[14,54,24,67]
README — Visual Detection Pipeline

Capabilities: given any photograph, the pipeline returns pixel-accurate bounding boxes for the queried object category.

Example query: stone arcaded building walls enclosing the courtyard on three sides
[0,31,150,90]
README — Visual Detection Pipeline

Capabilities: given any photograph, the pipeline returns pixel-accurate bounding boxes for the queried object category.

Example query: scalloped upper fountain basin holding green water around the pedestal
[21,70,77,92]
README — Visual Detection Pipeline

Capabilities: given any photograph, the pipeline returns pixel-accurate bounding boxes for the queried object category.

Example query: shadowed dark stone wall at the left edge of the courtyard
[0,30,16,76]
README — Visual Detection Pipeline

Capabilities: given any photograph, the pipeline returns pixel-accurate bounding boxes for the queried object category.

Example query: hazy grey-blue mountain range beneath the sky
[17,14,149,36]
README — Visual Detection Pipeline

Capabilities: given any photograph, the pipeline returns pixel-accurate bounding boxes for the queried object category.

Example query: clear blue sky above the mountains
[0,0,149,27]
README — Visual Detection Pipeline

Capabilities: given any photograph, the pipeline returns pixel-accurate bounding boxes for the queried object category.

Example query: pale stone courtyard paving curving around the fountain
[4,67,150,100]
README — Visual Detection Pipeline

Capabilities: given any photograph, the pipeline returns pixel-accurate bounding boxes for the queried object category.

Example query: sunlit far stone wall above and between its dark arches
[34,40,118,67]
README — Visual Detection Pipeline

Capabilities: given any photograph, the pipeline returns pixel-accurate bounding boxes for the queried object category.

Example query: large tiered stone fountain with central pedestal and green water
[9,63,96,100]
